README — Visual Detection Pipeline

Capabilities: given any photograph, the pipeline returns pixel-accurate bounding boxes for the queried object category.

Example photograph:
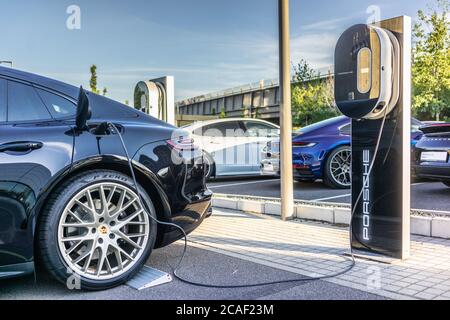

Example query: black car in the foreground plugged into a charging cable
[0,67,212,290]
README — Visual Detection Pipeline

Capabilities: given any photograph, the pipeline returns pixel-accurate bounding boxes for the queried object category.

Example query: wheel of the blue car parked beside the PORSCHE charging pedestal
[324,146,352,189]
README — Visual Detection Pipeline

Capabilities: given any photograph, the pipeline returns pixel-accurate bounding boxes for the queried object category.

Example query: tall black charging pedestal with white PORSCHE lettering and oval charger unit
[335,16,411,259]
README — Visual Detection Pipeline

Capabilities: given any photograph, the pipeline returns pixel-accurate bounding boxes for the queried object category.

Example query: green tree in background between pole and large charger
[292,60,338,127]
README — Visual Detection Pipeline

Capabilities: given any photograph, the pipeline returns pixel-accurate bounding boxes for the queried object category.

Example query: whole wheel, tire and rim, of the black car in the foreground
[39,170,157,290]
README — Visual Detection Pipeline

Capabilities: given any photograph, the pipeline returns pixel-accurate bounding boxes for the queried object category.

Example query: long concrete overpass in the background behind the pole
[176,68,333,124]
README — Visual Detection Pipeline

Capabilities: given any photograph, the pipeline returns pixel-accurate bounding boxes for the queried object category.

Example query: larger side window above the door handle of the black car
[8,81,52,122]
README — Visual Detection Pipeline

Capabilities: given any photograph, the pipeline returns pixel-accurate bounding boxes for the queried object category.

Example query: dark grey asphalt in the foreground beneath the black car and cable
[0,242,384,300]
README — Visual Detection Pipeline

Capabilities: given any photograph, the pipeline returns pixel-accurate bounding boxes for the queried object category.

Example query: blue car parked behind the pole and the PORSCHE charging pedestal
[261,116,422,189]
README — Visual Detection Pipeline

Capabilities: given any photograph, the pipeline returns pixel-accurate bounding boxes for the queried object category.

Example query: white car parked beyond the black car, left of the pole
[183,118,280,178]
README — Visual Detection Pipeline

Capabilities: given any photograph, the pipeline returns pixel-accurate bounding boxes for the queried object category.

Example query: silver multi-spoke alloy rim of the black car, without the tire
[58,182,150,280]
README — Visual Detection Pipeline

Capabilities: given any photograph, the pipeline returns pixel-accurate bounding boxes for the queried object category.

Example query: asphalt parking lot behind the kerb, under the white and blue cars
[208,177,450,215]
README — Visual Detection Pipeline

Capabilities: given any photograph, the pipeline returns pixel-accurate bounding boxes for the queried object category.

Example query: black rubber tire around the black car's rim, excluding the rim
[38,170,157,290]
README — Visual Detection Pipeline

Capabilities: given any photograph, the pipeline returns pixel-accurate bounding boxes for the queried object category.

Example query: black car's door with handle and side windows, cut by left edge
[0,78,75,266]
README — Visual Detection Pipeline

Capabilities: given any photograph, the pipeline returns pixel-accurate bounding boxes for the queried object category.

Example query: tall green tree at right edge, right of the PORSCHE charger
[412,0,450,121]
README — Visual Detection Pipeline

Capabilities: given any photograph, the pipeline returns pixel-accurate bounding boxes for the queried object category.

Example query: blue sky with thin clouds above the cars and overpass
[0,0,433,104]
